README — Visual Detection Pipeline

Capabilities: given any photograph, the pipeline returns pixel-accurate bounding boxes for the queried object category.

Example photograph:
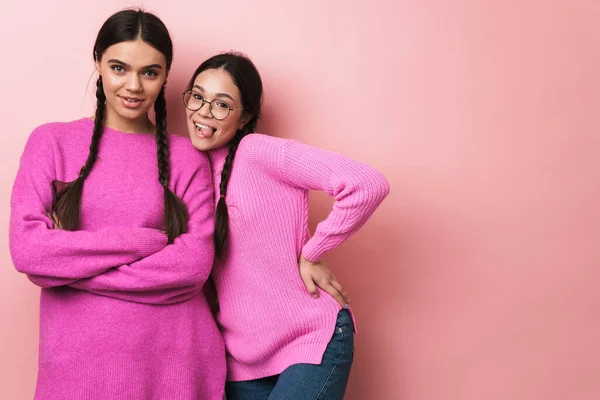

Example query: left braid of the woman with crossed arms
[52,76,106,231]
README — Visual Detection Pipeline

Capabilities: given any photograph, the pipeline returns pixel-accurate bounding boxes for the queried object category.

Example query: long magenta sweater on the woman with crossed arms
[10,118,226,400]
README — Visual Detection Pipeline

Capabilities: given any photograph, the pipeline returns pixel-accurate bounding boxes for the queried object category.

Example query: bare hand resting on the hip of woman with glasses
[298,256,350,308]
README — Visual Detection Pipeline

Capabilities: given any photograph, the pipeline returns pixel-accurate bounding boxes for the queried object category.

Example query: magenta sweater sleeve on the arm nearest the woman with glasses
[71,153,214,304]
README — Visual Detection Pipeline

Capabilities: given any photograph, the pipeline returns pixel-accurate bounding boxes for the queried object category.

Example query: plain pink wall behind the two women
[0,0,600,400]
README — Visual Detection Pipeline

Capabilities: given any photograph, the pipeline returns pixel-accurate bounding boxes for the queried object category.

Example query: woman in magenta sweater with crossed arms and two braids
[10,10,226,400]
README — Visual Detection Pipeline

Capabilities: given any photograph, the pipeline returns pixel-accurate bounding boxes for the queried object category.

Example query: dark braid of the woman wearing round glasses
[215,130,252,256]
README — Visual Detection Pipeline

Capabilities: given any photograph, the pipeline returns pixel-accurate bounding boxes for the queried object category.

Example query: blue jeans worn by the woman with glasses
[226,310,354,400]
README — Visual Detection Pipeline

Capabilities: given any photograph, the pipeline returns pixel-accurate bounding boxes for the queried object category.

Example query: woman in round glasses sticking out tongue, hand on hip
[183,53,389,400]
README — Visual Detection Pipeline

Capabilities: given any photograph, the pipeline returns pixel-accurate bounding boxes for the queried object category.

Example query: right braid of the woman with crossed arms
[154,87,189,243]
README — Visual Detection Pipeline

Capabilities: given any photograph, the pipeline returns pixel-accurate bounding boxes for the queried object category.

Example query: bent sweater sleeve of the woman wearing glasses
[270,140,390,262]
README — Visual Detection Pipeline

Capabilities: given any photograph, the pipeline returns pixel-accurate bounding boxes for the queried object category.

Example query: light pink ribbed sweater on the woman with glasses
[210,134,389,381]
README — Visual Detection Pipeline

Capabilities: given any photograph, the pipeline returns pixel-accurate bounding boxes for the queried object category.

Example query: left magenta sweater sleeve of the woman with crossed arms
[9,128,167,287]
